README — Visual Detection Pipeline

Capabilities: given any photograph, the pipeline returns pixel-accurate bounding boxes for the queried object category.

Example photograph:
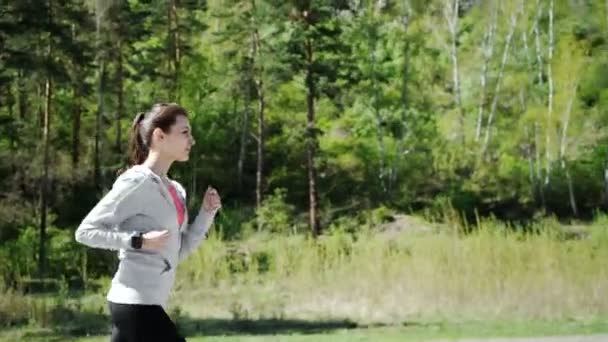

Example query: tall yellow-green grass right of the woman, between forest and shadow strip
[174,221,608,323]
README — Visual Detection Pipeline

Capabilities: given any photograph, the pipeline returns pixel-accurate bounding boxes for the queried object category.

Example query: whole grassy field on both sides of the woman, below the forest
[0,219,608,341]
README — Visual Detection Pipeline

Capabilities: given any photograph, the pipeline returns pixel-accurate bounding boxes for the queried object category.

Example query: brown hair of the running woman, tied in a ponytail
[129,103,188,166]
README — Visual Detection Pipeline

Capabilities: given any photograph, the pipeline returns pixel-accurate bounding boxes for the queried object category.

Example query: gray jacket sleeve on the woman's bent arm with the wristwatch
[75,174,146,250]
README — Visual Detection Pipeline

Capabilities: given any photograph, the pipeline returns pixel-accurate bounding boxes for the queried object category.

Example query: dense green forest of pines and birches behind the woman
[0,0,608,340]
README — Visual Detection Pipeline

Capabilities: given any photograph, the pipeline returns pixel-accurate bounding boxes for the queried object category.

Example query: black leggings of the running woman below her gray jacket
[108,302,186,342]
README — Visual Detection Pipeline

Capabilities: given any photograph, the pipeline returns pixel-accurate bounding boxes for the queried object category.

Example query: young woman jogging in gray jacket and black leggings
[75,104,221,342]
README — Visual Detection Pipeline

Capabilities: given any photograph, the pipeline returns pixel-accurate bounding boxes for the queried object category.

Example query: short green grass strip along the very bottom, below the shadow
[0,320,608,342]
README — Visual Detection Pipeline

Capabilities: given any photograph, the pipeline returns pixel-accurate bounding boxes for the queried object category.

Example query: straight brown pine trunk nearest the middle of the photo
[305,37,320,237]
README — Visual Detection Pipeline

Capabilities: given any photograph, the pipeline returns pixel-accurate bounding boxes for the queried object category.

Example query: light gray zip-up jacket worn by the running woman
[75,165,215,307]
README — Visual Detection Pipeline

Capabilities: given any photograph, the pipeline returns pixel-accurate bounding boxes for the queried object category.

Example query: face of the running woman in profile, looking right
[154,115,195,161]
